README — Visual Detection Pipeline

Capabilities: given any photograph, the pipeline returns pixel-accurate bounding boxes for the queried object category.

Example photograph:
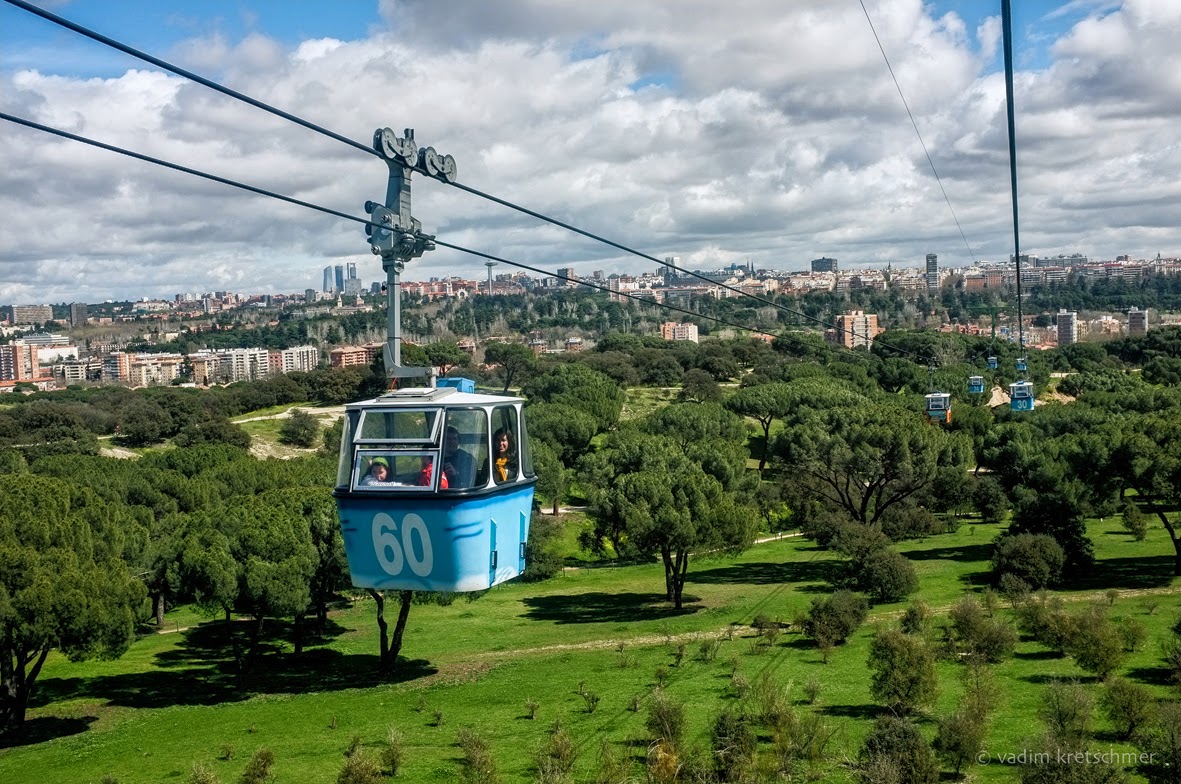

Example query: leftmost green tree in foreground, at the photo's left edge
[0,476,146,732]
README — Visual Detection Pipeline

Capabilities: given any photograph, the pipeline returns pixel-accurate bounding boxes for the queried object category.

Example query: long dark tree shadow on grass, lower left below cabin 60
[31,622,437,708]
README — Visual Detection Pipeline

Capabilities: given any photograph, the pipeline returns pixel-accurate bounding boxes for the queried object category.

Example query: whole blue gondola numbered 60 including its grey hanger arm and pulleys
[332,128,537,592]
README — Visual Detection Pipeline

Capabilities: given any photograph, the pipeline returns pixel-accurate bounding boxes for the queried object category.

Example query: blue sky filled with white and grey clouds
[0,0,1181,303]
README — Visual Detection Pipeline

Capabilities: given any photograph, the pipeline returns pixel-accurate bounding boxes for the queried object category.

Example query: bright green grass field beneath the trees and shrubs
[0,516,1179,784]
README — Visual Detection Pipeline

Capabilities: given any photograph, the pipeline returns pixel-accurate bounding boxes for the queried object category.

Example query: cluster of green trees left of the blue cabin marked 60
[0,444,347,731]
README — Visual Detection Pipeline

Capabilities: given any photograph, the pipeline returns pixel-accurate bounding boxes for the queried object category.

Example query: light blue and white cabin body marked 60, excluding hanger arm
[333,387,536,592]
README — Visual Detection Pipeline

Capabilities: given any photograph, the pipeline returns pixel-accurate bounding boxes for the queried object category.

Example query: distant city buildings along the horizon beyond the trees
[0,254,1181,392]
